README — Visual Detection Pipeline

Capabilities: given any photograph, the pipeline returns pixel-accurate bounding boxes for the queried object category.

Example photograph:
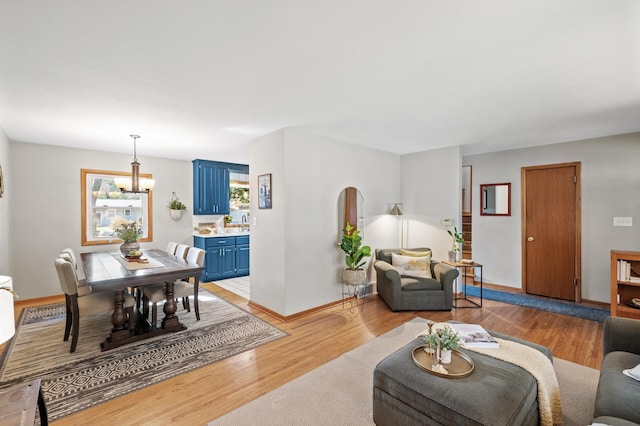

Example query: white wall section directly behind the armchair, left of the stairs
[400,147,462,260]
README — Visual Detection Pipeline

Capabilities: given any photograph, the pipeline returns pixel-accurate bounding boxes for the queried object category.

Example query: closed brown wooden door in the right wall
[522,163,580,302]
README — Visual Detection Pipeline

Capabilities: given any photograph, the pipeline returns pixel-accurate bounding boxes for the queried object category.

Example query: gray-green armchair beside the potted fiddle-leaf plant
[373,248,459,311]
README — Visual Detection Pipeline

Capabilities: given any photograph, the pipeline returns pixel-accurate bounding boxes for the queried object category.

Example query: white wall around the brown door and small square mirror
[463,133,640,303]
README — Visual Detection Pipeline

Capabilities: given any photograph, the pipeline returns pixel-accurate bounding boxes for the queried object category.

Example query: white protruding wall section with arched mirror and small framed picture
[249,129,400,315]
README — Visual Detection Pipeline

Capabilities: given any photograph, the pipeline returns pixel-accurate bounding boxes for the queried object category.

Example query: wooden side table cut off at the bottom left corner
[0,379,49,426]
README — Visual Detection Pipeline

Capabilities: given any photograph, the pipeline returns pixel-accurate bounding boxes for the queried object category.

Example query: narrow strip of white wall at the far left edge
[0,127,10,274]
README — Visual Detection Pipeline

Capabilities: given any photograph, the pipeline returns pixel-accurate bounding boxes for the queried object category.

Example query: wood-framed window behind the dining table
[80,169,153,246]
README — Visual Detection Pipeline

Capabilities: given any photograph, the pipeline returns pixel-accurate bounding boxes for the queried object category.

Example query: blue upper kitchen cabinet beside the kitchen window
[193,160,234,215]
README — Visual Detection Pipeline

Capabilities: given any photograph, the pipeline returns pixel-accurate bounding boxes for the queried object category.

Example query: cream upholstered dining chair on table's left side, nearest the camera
[54,257,134,352]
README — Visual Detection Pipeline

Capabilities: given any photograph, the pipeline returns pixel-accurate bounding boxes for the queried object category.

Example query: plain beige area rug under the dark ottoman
[208,318,599,426]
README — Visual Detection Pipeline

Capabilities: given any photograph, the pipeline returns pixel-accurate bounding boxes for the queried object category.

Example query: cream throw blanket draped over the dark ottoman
[420,323,563,426]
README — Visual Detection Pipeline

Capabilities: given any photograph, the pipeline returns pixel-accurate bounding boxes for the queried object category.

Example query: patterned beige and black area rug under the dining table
[0,289,288,421]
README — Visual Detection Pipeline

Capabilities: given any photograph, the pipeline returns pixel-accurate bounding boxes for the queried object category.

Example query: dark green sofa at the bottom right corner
[593,317,640,426]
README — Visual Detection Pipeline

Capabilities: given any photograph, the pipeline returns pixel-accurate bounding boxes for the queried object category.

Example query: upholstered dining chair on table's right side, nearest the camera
[142,247,205,327]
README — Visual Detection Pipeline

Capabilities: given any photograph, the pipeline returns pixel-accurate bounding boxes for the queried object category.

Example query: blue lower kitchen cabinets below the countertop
[193,236,249,281]
